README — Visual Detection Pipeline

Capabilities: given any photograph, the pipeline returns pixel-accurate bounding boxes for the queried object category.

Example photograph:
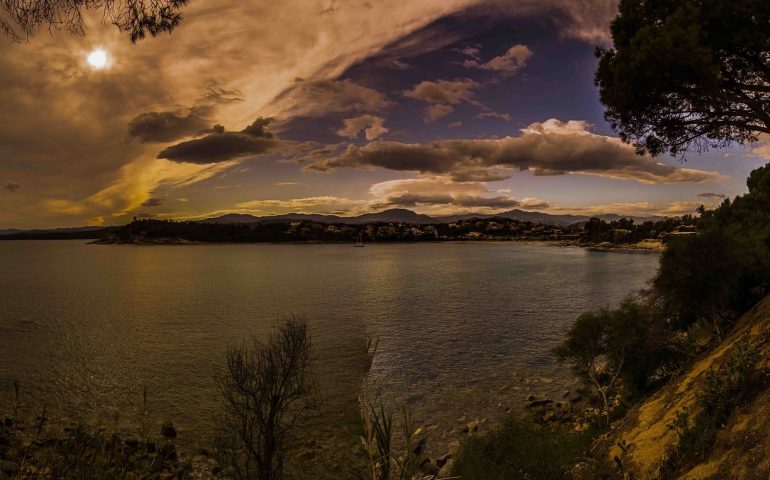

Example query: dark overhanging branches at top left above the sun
[0,0,189,42]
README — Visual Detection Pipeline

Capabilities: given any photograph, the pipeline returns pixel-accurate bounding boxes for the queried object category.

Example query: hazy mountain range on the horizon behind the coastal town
[201,208,666,226]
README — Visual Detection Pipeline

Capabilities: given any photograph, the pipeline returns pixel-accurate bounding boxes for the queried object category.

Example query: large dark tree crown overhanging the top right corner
[595,0,770,156]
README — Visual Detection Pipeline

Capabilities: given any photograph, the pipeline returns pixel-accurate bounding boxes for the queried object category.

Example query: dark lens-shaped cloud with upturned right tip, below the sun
[158,118,281,164]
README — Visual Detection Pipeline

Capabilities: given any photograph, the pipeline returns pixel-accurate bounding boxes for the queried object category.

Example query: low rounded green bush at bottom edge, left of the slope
[452,418,593,480]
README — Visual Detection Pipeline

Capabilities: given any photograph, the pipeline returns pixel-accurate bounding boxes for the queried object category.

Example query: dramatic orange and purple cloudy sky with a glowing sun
[0,0,770,228]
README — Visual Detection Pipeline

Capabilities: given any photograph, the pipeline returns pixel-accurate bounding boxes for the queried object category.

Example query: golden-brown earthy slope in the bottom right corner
[609,296,770,479]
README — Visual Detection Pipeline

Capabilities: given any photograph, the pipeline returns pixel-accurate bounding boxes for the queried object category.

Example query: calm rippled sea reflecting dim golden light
[0,241,658,456]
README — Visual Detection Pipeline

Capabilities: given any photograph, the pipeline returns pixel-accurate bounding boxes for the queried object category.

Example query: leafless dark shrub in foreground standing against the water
[214,317,316,480]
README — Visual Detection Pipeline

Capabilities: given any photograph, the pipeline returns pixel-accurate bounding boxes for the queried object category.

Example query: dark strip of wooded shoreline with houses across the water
[90,216,697,250]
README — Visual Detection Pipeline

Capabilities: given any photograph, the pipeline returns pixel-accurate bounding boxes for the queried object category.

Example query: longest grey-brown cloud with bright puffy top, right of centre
[305,119,722,184]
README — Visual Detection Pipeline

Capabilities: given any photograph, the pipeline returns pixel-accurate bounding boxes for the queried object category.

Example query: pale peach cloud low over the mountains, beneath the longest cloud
[368,176,548,215]
